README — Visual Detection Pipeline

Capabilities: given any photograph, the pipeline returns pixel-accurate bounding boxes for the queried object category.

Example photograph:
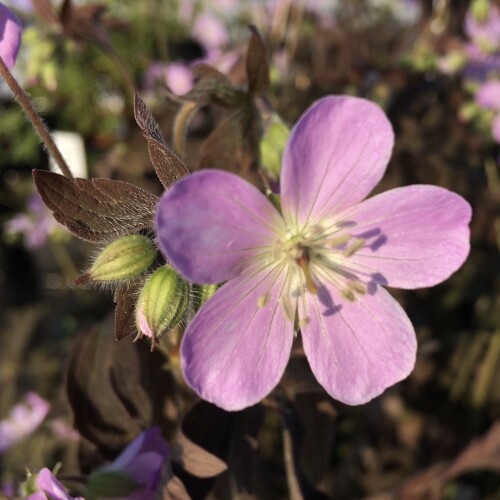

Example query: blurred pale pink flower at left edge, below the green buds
[0,392,50,453]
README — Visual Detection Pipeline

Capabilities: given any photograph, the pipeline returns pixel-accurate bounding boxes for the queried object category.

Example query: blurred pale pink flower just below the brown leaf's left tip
[5,193,61,250]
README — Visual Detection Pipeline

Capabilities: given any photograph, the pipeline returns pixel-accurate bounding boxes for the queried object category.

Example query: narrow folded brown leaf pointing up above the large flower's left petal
[134,94,189,189]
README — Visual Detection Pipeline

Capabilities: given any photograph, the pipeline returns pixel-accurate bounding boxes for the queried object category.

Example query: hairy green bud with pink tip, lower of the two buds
[135,265,189,350]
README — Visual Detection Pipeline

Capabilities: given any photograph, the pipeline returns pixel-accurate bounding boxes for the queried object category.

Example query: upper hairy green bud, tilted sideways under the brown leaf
[75,234,156,285]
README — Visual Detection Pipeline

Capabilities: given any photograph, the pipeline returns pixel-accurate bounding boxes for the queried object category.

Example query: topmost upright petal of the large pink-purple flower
[281,96,394,229]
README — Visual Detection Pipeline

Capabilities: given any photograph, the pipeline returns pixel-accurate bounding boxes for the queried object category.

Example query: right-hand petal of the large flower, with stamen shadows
[341,185,471,289]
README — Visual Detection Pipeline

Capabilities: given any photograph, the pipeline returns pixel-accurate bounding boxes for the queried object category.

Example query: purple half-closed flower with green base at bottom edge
[87,427,170,500]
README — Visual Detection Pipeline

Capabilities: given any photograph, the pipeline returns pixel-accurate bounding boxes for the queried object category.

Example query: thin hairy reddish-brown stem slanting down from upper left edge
[0,57,73,179]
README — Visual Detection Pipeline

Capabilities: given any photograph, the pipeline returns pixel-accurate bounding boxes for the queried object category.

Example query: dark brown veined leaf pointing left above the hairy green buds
[33,170,158,242]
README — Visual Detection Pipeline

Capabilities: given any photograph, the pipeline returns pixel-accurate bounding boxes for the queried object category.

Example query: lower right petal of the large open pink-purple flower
[302,285,417,405]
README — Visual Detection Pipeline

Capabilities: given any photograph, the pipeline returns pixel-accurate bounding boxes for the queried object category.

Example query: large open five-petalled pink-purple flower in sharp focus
[156,96,471,410]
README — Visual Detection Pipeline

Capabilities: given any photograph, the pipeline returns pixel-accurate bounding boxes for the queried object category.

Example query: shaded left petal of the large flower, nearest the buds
[156,170,284,283]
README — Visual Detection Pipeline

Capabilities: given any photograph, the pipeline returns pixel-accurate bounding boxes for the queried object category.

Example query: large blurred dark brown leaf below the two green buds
[66,317,179,458]
